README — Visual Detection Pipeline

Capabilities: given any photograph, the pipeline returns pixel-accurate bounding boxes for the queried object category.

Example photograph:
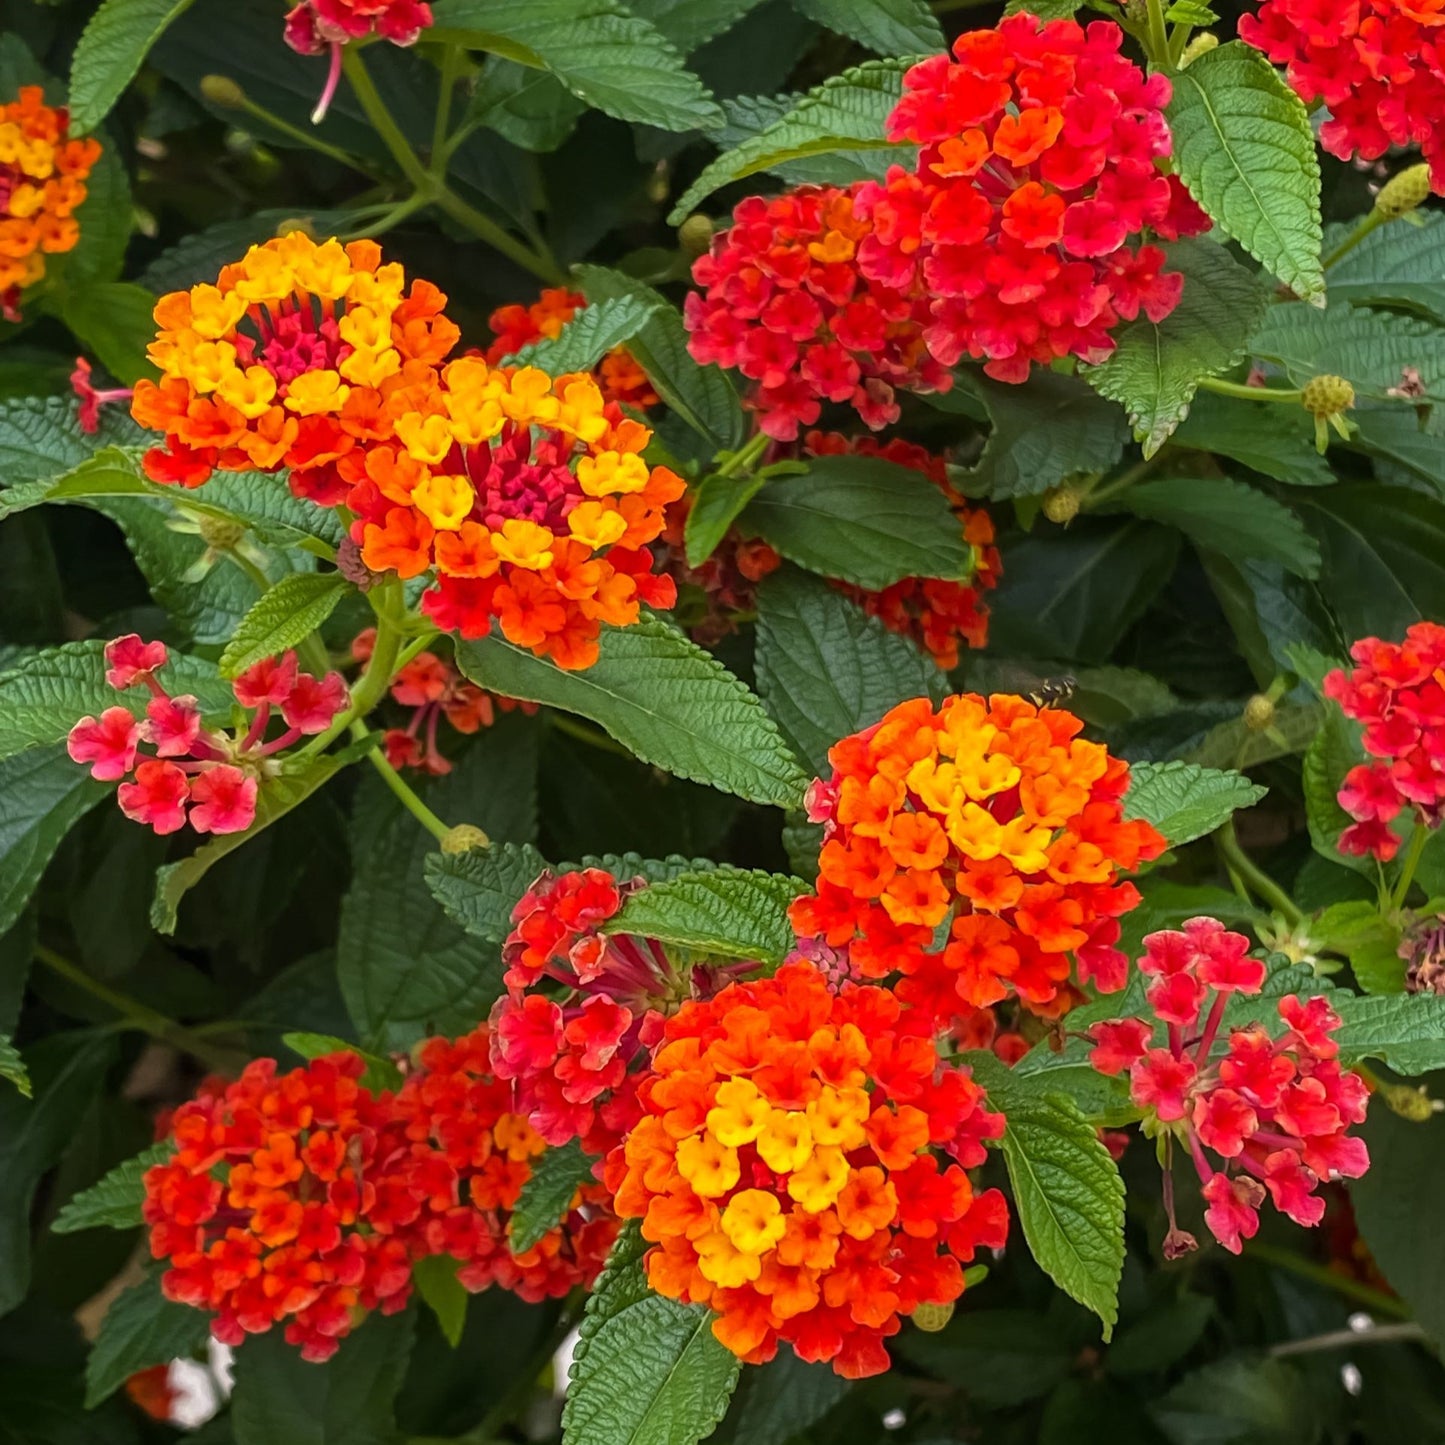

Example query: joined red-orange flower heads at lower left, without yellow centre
[143,1026,618,1360]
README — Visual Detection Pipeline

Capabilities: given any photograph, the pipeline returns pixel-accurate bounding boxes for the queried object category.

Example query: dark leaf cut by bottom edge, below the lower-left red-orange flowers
[231,1312,416,1445]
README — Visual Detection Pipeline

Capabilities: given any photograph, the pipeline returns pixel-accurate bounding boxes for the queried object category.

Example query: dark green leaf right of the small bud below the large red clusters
[1120,477,1319,577]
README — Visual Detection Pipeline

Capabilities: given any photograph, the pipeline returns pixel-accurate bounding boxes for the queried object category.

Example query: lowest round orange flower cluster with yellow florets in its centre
[607,962,1007,1377]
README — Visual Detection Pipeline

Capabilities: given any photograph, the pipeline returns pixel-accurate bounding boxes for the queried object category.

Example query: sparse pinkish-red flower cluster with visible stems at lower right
[1090,918,1370,1257]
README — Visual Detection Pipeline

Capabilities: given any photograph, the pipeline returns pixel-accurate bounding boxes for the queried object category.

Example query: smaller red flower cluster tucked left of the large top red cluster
[683,186,952,441]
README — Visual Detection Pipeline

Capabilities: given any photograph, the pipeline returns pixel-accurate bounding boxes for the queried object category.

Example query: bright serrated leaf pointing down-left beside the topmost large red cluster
[668,59,910,225]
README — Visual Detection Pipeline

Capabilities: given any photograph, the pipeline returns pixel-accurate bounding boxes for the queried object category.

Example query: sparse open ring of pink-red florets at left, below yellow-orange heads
[66,633,347,834]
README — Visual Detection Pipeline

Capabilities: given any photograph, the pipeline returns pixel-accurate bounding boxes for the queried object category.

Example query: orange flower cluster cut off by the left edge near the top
[0,85,100,321]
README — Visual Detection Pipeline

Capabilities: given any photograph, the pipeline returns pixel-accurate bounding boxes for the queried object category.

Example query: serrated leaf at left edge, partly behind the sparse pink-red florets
[0,637,236,760]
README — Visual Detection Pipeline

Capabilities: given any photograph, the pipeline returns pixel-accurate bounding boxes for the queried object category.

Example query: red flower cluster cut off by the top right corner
[1240,0,1445,194]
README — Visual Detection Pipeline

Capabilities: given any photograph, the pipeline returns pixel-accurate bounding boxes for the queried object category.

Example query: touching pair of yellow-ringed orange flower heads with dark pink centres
[131,231,683,668]
